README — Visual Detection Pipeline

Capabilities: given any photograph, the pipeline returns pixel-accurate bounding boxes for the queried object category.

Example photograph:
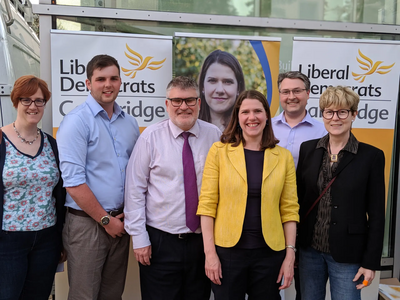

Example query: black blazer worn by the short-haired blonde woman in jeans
[297,140,385,270]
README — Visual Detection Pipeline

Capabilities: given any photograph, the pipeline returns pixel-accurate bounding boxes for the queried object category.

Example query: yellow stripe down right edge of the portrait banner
[262,41,281,117]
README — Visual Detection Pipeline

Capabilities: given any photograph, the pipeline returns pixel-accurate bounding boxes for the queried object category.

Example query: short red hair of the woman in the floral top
[10,75,51,108]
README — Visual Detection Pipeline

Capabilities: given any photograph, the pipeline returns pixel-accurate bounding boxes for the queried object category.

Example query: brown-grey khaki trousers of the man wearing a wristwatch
[63,212,129,300]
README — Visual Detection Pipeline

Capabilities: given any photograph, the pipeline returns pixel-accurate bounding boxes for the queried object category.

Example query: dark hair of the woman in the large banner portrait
[199,50,245,122]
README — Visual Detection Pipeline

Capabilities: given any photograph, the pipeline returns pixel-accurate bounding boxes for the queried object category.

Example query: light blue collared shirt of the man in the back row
[272,112,328,168]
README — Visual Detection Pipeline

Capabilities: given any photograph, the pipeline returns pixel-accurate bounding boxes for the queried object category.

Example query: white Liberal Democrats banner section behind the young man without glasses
[51,30,172,134]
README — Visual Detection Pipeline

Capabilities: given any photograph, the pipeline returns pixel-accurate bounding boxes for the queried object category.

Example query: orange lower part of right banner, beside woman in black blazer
[351,128,394,210]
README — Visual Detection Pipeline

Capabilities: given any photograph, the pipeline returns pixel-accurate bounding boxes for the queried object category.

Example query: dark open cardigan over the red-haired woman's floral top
[0,132,66,239]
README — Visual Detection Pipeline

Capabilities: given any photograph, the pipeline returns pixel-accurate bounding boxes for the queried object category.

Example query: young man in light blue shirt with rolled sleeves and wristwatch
[57,55,139,300]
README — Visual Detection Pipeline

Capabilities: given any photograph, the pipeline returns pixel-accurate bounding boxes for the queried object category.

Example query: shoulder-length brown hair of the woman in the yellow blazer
[221,90,279,150]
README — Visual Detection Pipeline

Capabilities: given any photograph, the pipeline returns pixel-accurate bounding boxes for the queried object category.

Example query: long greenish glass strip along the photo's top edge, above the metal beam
[51,0,400,24]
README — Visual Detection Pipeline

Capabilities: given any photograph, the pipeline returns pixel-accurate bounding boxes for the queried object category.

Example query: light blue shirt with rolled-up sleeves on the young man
[57,95,139,211]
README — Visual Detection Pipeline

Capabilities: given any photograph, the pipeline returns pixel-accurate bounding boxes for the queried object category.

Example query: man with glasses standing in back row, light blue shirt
[272,71,328,167]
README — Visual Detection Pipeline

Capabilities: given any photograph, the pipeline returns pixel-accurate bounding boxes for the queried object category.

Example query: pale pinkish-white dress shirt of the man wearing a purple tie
[124,120,221,249]
